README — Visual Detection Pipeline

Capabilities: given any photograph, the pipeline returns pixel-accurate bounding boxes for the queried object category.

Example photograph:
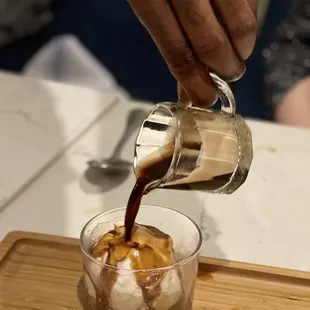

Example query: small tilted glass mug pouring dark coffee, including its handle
[134,74,253,194]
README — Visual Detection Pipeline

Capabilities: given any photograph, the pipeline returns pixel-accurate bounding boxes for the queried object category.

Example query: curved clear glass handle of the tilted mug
[210,72,236,115]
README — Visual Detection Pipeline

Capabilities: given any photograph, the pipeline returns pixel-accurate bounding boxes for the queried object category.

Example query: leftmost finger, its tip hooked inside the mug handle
[128,0,217,106]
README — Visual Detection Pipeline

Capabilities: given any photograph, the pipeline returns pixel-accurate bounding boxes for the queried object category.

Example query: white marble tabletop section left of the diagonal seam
[0,72,117,209]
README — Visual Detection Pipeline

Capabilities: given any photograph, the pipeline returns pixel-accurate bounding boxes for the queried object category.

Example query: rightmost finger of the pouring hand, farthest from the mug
[213,0,257,60]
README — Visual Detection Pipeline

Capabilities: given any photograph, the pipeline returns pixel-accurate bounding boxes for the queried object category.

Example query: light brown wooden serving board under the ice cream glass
[0,232,310,310]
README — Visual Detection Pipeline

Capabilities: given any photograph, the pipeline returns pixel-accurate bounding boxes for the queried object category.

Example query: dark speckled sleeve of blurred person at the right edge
[263,0,310,118]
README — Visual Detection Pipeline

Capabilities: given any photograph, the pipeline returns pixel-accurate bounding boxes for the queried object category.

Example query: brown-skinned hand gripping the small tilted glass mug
[128,0,257,106]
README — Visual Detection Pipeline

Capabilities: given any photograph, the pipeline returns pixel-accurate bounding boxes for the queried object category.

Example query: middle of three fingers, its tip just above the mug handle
[171,0,244,80]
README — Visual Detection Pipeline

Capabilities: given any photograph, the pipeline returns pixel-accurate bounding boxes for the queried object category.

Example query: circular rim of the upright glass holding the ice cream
[80,205,202,273]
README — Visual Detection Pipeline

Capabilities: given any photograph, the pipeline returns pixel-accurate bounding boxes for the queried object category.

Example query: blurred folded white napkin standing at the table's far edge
[23,35,130,99]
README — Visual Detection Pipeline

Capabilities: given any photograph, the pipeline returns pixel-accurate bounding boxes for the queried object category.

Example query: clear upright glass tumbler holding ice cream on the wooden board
[80,205,202,310]
